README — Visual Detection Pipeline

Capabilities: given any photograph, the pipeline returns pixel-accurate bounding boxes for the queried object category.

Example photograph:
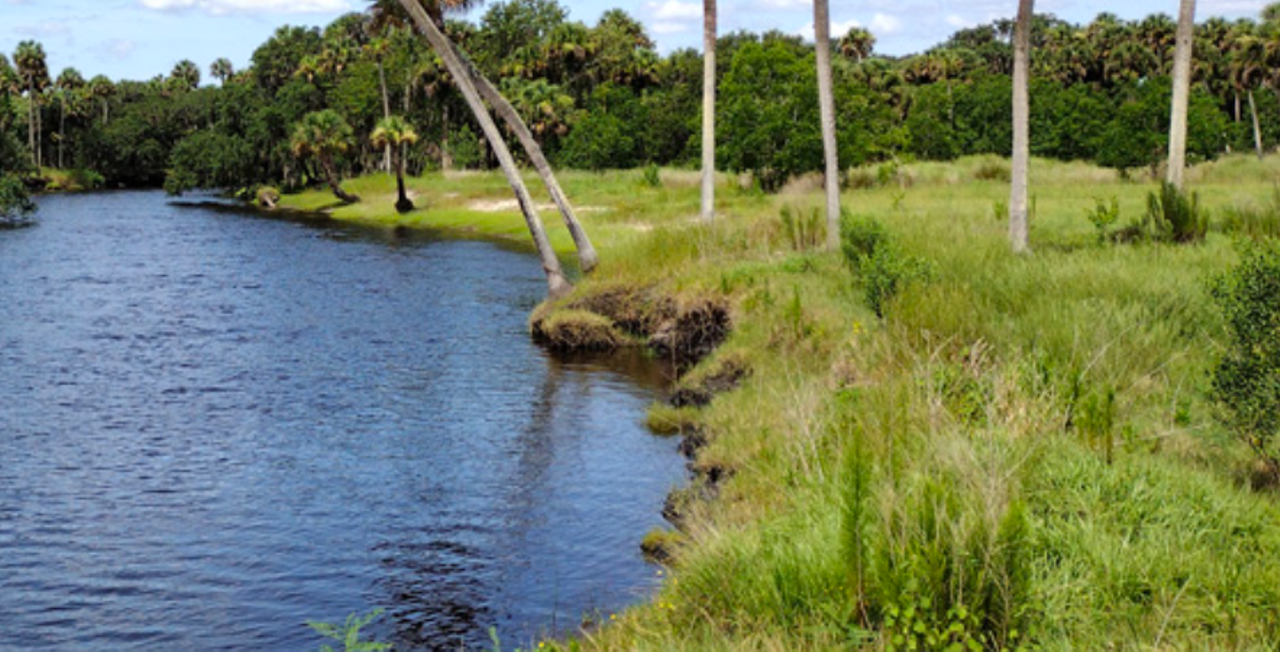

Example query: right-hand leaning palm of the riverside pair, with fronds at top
[371,0,603,273]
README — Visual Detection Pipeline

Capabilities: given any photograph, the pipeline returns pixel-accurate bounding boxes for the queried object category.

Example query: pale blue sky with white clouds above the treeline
[0,0,1266,79]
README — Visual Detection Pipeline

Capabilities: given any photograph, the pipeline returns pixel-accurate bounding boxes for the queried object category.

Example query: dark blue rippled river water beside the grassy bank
[0,193,682,649]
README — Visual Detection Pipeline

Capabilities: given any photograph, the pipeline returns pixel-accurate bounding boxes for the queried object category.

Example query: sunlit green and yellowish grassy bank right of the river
[284,158,1280,649]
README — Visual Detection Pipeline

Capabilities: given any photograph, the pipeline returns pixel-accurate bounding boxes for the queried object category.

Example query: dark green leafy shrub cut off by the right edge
[1212,241,1280,473]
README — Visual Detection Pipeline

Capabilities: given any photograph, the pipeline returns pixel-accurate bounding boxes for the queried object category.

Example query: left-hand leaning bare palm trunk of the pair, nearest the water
[399,0,573,298]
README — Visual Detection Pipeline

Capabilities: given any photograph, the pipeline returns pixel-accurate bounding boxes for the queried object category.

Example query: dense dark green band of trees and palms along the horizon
[0,0,1280,191]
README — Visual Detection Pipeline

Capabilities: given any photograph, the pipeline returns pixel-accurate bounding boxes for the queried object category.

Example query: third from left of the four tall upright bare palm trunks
[1009,0,1036,254]
